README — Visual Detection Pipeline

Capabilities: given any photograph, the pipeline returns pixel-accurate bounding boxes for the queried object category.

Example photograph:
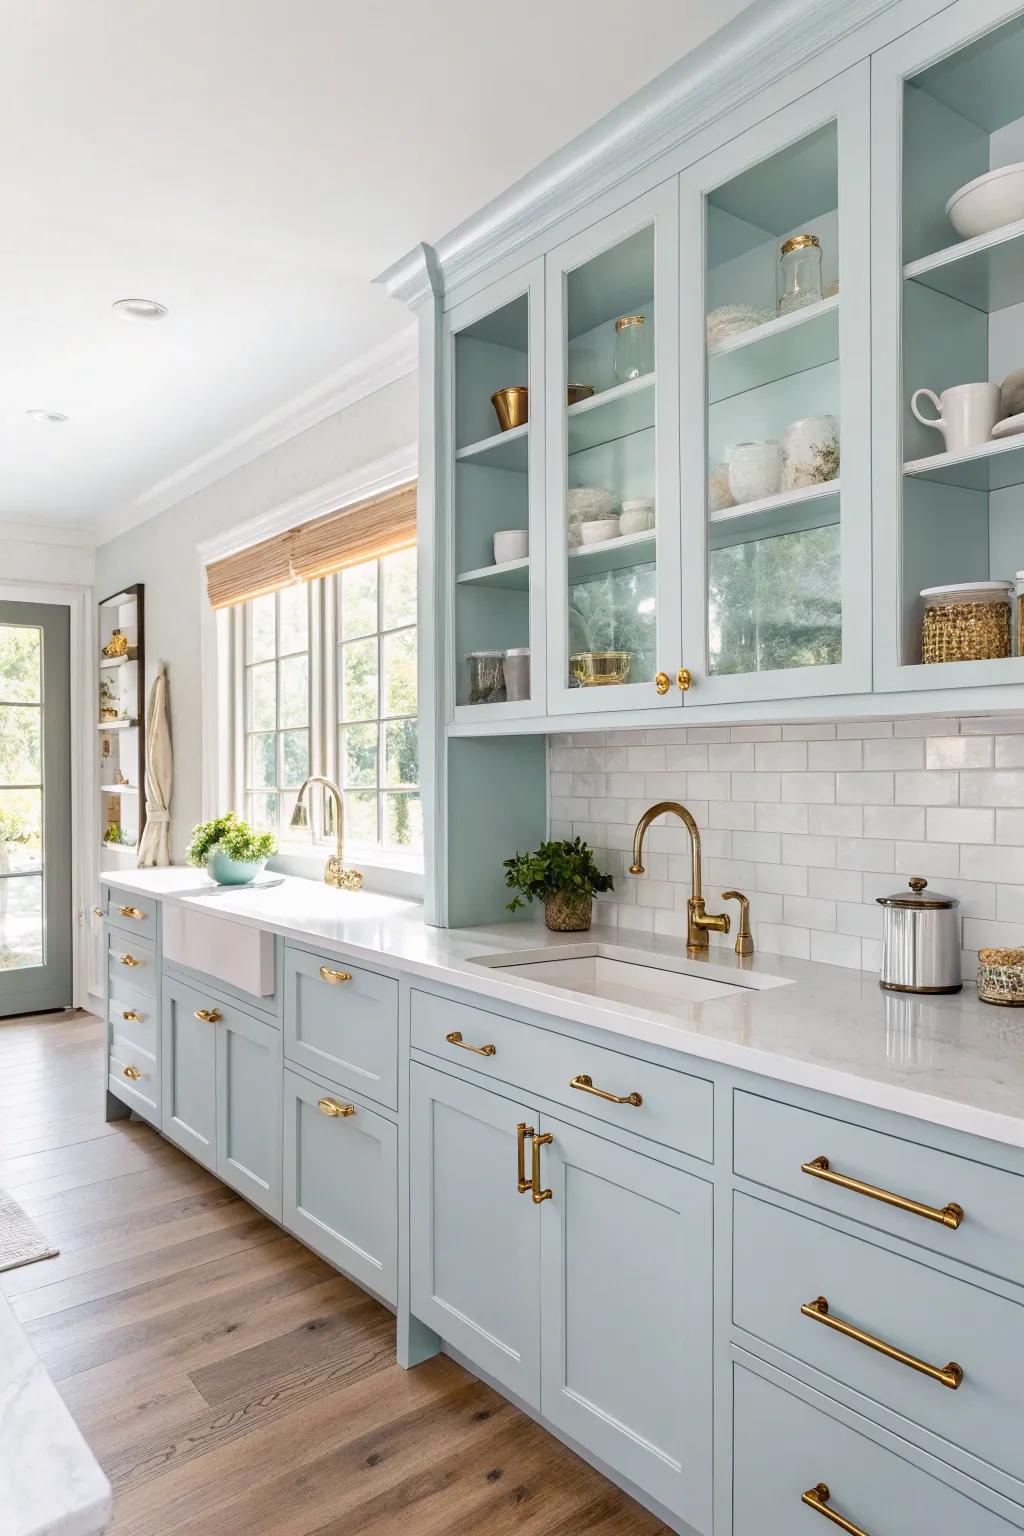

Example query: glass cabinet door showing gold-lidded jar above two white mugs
[680,65,870,703]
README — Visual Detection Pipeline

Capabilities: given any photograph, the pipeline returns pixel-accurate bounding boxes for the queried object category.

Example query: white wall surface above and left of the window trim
[97,373,418,859]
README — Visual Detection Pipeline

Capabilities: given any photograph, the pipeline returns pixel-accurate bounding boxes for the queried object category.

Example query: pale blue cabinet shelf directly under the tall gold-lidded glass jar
[708,293,840,406]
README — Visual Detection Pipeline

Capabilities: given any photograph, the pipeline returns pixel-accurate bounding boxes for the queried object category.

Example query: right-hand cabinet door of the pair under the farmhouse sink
[216,1005,282,1221]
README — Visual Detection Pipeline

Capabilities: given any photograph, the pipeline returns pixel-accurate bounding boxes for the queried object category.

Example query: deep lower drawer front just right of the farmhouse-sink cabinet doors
[284,1068,398,1306]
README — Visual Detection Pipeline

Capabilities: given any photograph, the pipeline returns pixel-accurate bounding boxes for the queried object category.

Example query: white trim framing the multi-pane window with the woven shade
[197,442,424,900]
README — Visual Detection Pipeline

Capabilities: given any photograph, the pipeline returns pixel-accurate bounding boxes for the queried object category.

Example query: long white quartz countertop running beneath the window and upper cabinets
[101,868,1024,1147]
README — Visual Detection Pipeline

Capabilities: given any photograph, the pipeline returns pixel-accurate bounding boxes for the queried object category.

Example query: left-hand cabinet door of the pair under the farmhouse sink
[161,977,216,1169]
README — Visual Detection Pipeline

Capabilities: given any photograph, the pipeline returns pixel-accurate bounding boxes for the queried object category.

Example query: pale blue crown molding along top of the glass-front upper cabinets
[376,0,900,309]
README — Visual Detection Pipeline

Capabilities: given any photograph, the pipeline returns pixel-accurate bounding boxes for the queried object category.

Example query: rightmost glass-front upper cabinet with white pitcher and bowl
[872,0,1024,690]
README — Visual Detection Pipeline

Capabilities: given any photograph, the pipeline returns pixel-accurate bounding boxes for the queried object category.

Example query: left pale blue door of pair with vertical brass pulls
[410,1061,543,1407]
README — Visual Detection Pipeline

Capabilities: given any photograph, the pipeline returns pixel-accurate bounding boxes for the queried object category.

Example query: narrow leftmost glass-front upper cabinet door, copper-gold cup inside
[445,261,545,722]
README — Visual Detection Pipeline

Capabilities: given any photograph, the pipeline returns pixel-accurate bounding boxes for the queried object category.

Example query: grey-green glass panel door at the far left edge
[0,602,71,1017]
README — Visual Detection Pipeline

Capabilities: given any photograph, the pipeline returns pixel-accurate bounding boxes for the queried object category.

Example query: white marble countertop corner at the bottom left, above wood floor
[0,1295,111,1536]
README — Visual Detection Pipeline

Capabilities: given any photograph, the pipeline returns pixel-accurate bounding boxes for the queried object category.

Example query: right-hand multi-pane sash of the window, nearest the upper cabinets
[335,550,424,849]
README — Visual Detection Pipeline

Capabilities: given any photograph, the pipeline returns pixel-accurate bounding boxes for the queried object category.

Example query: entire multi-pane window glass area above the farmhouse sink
[236,548,422,856]
